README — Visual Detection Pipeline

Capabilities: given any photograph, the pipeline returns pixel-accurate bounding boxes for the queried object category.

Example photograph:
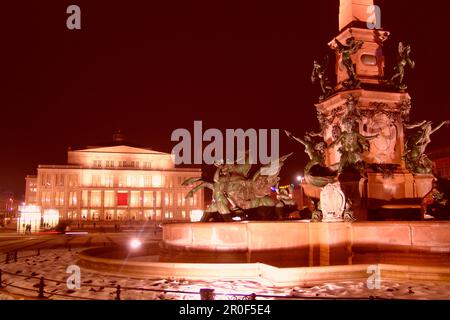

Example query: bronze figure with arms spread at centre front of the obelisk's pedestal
[328,122,378,173]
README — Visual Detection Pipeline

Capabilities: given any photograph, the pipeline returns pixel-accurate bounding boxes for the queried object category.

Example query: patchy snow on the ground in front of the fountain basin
[0,249,450,300]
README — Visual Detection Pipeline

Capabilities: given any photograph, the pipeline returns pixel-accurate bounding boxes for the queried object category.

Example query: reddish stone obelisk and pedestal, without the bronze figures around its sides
[310,0,433,220]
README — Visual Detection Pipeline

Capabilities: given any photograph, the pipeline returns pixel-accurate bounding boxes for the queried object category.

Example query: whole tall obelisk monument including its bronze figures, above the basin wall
[286,0,450,221]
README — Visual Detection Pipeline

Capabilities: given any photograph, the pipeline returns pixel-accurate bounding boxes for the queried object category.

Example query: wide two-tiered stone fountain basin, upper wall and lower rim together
[79,221,450,286]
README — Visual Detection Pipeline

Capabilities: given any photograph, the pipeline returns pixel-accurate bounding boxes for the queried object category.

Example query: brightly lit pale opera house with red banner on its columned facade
[25,134,204,221]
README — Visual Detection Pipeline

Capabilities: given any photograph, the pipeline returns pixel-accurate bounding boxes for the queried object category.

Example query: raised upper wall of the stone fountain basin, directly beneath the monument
[163,221,450,266]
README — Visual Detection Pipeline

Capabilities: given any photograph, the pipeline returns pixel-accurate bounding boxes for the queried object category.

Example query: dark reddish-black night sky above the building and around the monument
[0,0,450,197]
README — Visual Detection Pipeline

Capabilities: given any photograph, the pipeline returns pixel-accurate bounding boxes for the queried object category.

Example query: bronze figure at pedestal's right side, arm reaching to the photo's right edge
[403,120,450,174]
